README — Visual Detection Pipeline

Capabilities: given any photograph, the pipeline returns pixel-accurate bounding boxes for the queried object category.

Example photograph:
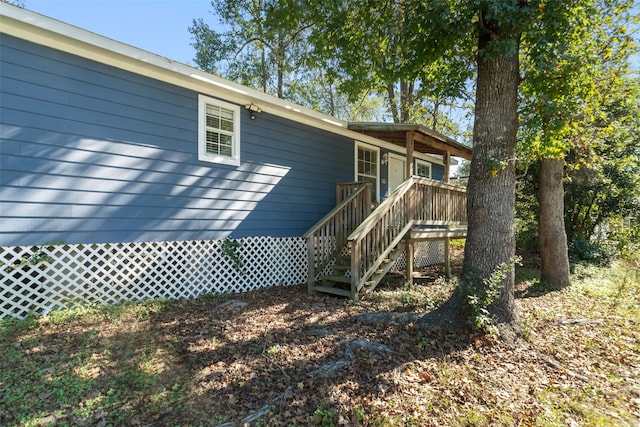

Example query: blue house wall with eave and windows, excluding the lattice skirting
[0,4,470,246]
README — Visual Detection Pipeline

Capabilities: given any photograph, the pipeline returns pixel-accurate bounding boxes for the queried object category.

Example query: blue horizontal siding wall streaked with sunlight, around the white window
[0,35,354,246]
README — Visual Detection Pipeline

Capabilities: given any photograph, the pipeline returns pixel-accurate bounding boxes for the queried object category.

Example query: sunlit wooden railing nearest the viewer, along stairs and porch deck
[348,177,466,294]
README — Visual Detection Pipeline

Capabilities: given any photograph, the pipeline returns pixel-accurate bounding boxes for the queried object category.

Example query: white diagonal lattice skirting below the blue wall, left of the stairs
[0,237,307,319]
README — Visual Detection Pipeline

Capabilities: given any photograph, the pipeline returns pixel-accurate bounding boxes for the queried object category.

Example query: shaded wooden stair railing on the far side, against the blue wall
[303,182,371,286]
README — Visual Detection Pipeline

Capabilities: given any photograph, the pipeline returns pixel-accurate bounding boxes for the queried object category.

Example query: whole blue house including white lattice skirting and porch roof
[0,2,471,319]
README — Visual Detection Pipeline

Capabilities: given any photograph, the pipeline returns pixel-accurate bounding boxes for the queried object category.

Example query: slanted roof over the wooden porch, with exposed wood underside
[347,122,471,160]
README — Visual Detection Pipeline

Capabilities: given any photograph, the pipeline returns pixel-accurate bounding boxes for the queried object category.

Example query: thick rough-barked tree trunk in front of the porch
[461,20,520,340]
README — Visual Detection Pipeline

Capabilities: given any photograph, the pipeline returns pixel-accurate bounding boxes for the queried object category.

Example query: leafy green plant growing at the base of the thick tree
[457,257,521,335]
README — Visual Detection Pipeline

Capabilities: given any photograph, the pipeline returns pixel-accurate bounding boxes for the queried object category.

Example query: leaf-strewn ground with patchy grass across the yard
[0,256,640,426]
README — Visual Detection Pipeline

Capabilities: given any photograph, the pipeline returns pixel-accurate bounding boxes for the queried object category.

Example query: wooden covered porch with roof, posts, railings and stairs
[304,123,471,300]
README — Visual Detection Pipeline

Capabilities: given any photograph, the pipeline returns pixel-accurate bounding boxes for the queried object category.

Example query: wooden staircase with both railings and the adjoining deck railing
[304,177,466,301]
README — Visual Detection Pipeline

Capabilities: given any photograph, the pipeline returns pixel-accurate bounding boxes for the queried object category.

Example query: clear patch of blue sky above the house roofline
[22,0,218,65]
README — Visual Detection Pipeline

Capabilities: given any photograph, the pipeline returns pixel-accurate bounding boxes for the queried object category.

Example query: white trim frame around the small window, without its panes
[198,95,240,166]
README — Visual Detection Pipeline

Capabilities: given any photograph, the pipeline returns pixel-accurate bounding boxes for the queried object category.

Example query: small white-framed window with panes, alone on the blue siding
[198,95,240,166]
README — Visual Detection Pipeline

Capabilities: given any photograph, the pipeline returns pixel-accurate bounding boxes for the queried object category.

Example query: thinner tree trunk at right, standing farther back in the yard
[538,159,569,289]
